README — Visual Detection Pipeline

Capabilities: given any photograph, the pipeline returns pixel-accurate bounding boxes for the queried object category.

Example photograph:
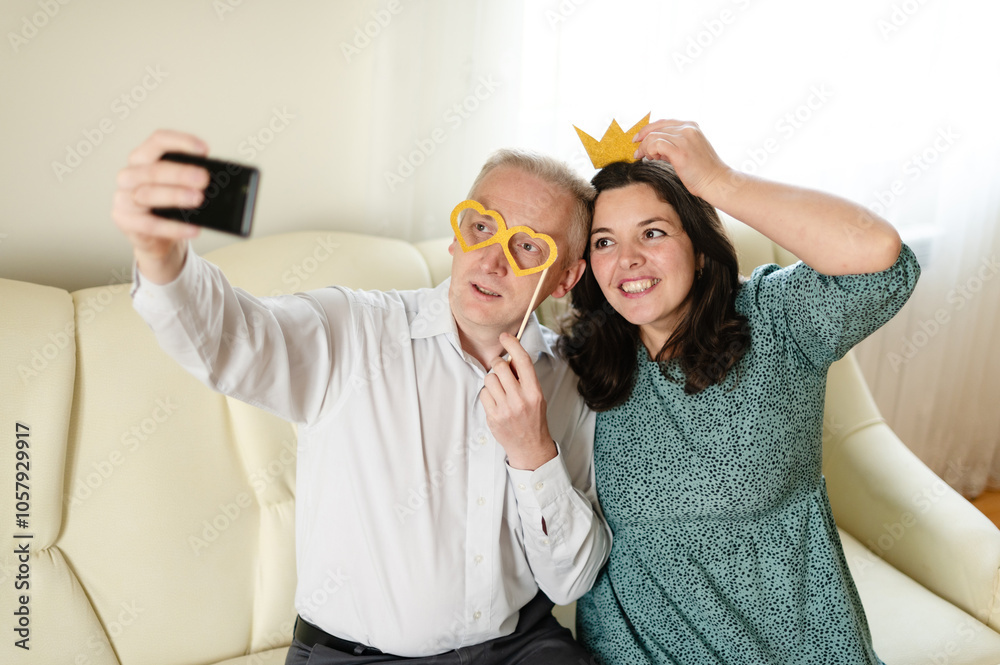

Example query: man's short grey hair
[469,148,597,268]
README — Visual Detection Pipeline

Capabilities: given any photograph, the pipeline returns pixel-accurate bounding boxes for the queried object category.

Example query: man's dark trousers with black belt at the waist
[285,592,597,665]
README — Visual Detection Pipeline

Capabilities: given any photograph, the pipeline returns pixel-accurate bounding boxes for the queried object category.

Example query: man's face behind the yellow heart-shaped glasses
[448,166,575,336]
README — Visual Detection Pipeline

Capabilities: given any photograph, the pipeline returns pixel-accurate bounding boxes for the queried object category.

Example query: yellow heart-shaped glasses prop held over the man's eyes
[451,199,559,277]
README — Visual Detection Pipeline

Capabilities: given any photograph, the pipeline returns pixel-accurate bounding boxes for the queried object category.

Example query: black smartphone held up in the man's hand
[153,152,260,238]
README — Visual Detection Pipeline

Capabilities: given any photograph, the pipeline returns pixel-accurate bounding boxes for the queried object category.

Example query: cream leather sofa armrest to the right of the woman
[823,355,1000,630]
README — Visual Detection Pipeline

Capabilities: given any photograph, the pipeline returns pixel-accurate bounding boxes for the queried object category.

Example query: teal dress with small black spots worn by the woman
[577,246,920,665]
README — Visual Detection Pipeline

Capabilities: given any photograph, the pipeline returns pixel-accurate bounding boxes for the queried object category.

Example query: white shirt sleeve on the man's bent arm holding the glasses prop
[507,434,611,605]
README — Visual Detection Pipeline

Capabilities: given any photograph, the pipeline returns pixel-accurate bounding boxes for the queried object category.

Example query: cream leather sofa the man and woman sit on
[0,225,1000,665]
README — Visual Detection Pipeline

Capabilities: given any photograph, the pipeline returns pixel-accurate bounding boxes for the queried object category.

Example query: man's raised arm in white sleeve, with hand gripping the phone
[112,130,352,422]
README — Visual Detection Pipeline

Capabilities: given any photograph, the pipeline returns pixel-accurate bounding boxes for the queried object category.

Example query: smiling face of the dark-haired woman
[590,183,701,356]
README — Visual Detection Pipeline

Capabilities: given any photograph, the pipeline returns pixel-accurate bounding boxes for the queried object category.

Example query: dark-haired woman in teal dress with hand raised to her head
[562,120,920,665]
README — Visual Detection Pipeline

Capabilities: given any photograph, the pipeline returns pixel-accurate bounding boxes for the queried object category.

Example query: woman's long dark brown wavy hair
[560,161,750,411]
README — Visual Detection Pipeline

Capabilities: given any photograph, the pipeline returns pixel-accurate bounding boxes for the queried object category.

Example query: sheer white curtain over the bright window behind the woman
[510,0,1000,496]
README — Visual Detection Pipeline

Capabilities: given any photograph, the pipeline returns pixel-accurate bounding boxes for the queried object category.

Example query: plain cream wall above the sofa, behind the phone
[0,0,514,290]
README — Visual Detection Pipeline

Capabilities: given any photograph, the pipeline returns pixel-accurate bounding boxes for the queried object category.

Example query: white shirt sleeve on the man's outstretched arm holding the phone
[132,241,353,423]
